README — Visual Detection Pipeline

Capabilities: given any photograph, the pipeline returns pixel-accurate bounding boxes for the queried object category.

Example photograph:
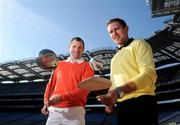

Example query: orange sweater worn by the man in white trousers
[44,61,94,108]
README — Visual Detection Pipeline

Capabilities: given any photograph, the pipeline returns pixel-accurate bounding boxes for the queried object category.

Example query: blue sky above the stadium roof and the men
[0,0,172,63]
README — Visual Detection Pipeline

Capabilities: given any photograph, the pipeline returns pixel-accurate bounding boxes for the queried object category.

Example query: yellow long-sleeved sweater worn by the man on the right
[110,39,157,102]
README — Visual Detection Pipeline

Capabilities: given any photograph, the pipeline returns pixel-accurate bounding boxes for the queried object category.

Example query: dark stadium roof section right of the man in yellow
[147,21,180,67]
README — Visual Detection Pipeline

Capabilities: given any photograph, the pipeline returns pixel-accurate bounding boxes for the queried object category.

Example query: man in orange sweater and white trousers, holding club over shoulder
[41,37,94,125]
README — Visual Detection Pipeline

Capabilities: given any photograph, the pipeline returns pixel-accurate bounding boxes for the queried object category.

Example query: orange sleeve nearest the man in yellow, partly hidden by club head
[61,63,94,101]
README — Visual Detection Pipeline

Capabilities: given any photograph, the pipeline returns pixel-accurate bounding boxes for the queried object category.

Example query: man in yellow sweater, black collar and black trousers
[97,18,158,125]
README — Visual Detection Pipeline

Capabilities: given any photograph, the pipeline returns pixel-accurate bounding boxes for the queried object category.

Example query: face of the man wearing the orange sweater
[69,40,84,59]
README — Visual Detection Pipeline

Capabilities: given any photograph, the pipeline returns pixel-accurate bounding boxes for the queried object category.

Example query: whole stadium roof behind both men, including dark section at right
[0,21,180,83]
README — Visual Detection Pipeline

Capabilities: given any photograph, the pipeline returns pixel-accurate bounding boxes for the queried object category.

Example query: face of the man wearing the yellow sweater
[107,22,128,45]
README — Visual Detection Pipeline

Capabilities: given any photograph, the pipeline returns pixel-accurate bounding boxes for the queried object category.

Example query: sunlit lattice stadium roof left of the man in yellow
[0,48,116,83]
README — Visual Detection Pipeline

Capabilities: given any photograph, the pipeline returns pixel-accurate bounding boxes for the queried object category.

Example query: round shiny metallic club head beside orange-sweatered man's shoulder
[36,49,58,70]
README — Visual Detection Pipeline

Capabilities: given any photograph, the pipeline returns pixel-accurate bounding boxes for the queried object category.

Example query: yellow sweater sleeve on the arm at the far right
[132,41,157,89]
